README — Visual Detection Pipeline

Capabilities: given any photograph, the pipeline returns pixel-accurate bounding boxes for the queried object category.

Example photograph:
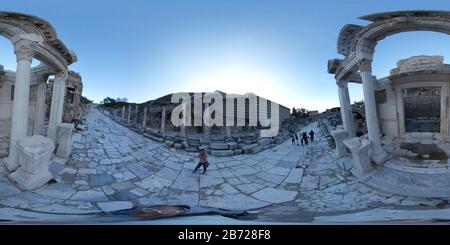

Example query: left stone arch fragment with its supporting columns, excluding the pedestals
[0,12,77,171]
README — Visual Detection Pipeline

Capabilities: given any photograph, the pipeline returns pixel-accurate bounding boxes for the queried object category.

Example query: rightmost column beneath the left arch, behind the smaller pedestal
[47,71,67,144]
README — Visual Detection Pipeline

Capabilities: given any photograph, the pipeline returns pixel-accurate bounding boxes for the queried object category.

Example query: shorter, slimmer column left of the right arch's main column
[337,81,356,138]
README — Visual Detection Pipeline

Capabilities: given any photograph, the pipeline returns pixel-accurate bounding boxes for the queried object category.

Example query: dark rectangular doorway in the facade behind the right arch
[402,87,441,133]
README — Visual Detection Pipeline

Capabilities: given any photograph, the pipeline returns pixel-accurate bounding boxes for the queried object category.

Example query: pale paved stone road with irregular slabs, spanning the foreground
[0,108,446,219]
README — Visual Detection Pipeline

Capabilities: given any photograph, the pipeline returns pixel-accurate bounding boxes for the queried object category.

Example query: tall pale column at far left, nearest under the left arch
[5,46,34,171]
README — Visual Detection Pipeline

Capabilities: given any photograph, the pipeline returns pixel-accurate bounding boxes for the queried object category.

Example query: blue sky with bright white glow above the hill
[0,0,450,111]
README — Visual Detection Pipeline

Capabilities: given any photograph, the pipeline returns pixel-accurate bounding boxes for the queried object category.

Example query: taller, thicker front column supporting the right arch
[359,59,387,164]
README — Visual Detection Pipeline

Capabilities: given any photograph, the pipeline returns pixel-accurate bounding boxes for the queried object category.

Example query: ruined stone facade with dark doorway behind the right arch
[375,55,450,137]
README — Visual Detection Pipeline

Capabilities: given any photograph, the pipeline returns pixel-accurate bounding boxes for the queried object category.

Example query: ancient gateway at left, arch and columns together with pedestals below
[0,12,82,189]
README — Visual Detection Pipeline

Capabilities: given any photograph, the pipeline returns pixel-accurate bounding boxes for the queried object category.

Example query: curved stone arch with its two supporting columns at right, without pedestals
[328,11,450,164]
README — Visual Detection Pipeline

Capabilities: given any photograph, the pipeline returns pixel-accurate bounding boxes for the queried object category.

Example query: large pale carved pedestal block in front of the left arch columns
[9,135,55,190]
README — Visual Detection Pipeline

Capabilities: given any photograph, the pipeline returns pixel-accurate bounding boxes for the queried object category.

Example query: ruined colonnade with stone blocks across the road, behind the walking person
[101,91,296,156]
